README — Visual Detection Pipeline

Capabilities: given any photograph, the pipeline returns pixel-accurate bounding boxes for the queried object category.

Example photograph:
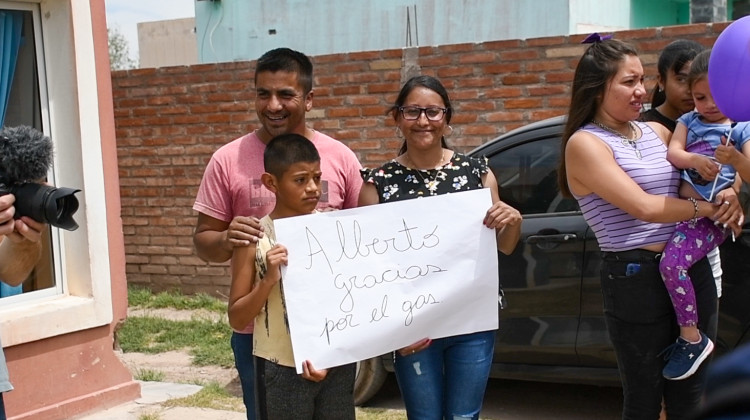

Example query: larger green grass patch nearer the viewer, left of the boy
[117,316,234,368]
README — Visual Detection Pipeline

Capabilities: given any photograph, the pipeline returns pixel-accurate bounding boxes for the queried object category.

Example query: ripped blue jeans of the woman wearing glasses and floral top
[394,330,495,420]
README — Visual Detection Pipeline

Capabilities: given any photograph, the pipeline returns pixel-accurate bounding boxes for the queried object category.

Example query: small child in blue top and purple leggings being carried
[659,50,750,380]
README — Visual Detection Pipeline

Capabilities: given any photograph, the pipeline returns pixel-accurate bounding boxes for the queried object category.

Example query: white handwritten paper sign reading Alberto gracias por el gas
[274,188,498,372]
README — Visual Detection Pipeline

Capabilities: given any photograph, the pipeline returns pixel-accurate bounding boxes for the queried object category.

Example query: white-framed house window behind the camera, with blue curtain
[0,0,114,346]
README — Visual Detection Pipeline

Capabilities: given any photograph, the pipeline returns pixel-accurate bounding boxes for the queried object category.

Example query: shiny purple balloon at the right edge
[708,16,750,121]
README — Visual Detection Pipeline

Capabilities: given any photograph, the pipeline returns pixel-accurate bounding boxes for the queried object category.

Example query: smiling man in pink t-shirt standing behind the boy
[193,48,362,419]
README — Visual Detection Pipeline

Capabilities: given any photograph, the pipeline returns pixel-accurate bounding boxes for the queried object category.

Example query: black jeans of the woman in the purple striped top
[601,251,718,420]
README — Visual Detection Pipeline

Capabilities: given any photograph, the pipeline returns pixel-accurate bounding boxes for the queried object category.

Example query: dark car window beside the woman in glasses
[488,137,578,215]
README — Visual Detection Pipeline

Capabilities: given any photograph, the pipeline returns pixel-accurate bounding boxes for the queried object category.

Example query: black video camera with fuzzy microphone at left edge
[0,126,81,230]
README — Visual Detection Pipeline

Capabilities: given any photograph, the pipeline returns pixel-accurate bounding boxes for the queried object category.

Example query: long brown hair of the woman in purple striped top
[557,39,638,197]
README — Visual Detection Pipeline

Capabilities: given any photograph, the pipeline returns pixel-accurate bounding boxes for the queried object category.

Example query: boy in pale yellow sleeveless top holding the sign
[228,134,355,420]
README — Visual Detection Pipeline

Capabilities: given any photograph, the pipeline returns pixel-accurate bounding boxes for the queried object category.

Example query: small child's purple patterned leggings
[659,217,730,327]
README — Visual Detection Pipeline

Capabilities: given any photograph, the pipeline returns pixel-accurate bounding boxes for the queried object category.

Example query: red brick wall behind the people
[112,23,727,296]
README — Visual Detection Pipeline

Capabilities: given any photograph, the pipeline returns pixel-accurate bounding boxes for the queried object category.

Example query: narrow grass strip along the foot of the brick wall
[128,287,227,313]
